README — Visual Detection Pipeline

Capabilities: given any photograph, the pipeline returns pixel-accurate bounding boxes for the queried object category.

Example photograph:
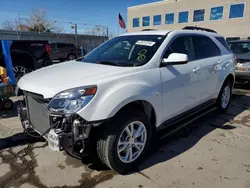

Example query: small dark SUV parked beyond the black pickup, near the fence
[50,42,79,60]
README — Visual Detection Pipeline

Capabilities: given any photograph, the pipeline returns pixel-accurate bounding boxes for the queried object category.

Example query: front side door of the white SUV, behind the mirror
[160,36,203,120]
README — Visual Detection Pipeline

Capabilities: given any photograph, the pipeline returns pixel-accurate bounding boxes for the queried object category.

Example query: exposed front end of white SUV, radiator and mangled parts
[18,91,97,158]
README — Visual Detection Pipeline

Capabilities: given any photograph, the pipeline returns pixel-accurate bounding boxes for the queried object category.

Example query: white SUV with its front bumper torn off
[18,28,235,173]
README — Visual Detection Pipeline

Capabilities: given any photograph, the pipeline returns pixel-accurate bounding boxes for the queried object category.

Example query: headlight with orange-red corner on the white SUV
[47,86,97,114]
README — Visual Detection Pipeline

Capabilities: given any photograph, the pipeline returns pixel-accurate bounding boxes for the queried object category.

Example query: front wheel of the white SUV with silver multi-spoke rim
[97,112,152,174]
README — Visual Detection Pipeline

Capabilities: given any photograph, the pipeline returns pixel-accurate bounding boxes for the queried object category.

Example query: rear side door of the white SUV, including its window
[192,35,223,104]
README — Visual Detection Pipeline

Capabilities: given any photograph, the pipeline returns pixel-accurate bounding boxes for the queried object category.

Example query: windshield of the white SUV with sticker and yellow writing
[82,35,165,66]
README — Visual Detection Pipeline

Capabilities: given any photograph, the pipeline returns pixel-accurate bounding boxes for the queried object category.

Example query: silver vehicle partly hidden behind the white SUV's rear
[229,40,250,82]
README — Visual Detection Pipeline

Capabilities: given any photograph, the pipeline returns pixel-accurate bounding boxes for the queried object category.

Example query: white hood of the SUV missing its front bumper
[18,61,136,98]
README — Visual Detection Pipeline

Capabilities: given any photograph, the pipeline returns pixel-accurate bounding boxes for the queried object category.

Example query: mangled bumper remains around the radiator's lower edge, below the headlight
[17,106,98,158]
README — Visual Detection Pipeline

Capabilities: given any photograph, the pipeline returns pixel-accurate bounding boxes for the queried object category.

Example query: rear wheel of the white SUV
[216,80,232,112]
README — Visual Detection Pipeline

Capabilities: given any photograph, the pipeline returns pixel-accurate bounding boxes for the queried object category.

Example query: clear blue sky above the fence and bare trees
[0,0,159,35]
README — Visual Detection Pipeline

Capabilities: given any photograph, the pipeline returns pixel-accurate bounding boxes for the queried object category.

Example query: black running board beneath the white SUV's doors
[160,107,217,139]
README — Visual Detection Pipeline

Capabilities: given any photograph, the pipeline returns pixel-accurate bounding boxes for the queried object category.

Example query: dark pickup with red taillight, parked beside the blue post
[0,40,52,80]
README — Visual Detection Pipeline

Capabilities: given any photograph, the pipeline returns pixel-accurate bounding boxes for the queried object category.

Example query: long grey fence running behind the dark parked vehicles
[0,30,108,52]
